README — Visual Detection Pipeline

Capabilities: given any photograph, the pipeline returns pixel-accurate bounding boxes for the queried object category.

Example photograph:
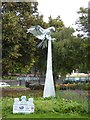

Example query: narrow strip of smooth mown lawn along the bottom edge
[7,113,89,120]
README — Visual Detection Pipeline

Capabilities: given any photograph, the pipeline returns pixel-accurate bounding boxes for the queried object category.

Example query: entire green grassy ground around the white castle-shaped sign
[2,90,88,118]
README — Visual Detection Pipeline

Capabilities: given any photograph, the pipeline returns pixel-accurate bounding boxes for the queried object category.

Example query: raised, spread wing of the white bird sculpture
[27,25,45,40]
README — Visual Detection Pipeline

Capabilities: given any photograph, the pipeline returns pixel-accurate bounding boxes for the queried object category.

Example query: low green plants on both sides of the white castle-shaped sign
[2,97,86,117]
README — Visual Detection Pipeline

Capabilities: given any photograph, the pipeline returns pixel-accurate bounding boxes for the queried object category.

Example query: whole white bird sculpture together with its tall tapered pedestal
[27,25,55,98]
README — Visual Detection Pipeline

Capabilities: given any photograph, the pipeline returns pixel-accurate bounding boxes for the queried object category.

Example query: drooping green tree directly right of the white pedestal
[53,27,88,76]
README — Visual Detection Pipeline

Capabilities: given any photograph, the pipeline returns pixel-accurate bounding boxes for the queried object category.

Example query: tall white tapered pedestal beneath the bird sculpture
[43,40,55,98]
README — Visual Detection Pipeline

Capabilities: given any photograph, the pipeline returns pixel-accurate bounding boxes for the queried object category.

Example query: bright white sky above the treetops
[37,0,90,27]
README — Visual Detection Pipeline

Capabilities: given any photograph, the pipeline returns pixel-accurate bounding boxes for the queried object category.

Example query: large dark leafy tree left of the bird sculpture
[2,2,44,75]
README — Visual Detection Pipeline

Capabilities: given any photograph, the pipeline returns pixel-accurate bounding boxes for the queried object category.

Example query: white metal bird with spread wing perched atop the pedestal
[27,25,55,48]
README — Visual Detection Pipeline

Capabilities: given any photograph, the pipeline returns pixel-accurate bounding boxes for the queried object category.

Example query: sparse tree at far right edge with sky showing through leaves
[76,7,90,71]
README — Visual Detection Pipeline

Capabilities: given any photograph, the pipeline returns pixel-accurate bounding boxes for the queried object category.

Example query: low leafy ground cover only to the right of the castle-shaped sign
[35,98,85,113]
